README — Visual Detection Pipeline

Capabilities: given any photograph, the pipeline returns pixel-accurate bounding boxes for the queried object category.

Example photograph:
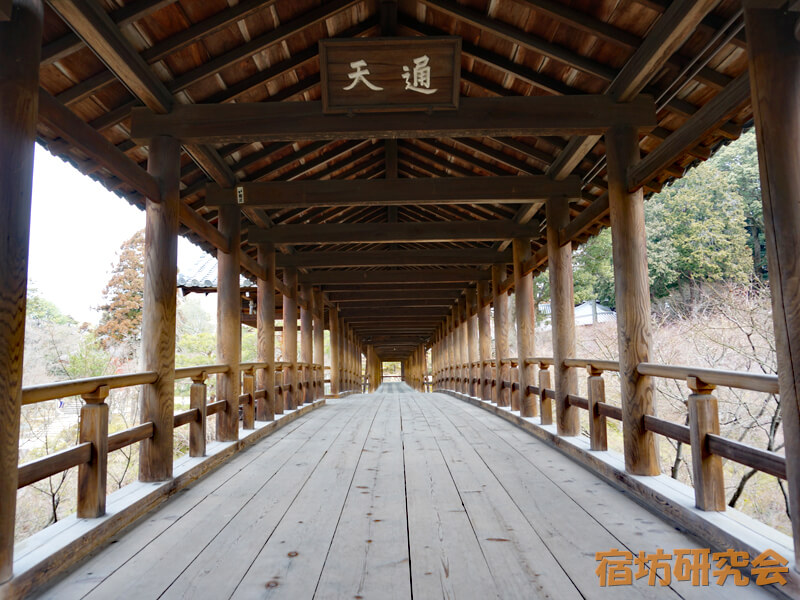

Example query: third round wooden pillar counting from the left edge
[217,205,242,442]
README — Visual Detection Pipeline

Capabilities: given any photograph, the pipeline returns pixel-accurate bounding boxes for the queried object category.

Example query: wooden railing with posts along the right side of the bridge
[434,357,786,511]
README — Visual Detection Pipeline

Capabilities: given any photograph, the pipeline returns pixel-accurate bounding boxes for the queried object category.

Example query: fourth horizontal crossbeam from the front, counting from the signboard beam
[277,248,511,268]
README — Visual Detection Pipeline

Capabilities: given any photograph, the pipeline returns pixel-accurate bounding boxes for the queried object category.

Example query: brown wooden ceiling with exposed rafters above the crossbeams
[38,0,752,359]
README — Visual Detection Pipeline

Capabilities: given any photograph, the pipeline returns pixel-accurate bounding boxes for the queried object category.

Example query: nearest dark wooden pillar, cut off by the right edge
[744,0,800,569]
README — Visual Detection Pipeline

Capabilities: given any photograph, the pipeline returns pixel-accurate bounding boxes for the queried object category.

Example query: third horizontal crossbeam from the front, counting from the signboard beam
[248,220,538,244]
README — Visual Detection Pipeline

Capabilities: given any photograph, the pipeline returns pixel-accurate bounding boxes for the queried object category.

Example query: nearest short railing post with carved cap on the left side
[78,385,108,519]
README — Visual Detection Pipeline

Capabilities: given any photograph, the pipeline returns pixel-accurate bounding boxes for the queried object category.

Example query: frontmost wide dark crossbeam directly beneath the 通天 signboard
[131,98,657,143]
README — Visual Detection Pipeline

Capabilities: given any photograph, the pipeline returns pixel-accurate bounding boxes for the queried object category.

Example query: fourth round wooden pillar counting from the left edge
[256,244,275,421]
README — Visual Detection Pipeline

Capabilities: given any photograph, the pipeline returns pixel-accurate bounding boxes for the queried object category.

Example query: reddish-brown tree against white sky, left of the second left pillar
[97,230,144,348]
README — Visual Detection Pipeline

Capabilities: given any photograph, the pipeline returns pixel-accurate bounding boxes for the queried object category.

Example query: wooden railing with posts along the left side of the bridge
[17,362,326,518]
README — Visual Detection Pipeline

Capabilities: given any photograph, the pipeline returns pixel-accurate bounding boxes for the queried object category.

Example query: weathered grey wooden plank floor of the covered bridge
[40,383,773,600]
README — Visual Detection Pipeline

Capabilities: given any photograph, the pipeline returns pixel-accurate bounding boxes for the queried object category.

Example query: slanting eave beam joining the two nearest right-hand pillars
[628,71,750,191]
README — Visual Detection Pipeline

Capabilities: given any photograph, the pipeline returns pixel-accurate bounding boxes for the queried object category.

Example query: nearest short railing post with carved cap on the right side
[686,377,725,511]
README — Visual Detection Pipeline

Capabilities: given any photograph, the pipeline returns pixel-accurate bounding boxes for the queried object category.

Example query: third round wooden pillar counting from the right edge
[544,203,576,435]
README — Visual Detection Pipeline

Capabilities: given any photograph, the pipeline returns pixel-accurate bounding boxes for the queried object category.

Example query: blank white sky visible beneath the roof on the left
[28,144,205,324]
